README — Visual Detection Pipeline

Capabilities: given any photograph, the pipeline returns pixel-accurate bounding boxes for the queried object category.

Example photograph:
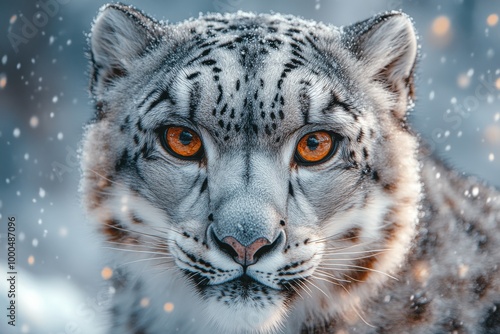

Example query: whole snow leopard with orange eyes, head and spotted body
[81,3,500,334]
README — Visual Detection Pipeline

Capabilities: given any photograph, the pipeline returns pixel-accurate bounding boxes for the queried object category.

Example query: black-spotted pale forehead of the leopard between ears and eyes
[137,13,356,145]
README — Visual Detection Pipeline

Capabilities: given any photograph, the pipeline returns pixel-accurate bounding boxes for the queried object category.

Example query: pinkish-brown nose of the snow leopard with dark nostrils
[212,233,281,267]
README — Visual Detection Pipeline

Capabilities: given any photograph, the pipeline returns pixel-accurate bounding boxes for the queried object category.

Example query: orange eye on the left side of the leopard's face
[163,126,203,160]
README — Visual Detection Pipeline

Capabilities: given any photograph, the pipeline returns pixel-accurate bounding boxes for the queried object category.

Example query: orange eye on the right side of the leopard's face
[295,131,337,165]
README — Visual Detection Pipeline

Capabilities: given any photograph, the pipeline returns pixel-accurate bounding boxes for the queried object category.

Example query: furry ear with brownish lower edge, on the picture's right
[342,12,417,118]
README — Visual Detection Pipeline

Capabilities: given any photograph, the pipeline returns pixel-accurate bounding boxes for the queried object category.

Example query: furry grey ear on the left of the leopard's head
[90,4,161,95]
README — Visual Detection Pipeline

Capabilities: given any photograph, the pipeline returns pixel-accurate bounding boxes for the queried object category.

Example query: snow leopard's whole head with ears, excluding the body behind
[83,5,419,332]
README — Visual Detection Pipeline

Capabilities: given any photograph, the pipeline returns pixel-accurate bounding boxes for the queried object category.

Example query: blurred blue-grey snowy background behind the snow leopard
[0,0,500,334]
